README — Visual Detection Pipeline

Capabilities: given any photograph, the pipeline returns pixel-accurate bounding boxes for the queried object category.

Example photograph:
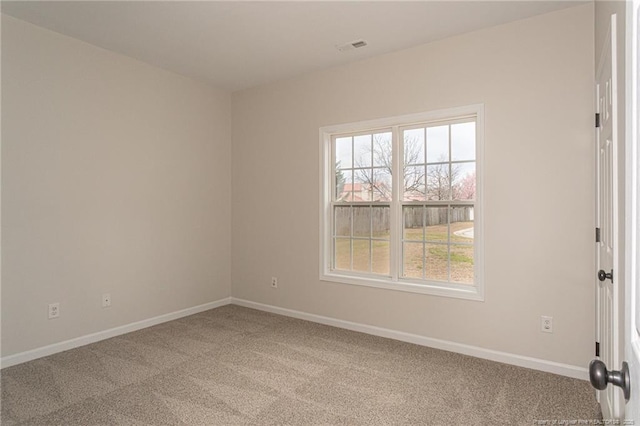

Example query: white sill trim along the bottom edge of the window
[320,272,484,302]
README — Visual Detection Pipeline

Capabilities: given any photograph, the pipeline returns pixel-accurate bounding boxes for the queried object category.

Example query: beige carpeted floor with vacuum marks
[1,305,601,426]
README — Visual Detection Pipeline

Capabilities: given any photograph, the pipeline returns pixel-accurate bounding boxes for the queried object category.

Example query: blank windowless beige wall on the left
[2,16,231,357]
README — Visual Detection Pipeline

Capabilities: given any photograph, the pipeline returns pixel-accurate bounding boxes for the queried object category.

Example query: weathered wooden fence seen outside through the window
[334,206,473,236]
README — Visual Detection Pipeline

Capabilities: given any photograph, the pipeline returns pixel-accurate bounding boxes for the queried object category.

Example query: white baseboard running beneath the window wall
[231,297,589,380]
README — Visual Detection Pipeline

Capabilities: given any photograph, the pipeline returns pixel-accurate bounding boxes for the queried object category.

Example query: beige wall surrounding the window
[232,4,594,367]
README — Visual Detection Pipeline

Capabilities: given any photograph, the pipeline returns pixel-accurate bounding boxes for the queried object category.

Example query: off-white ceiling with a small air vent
[1,0,584,91]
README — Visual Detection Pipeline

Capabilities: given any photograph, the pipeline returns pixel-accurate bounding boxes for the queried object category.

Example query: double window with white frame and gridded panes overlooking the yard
[320,105,483,300]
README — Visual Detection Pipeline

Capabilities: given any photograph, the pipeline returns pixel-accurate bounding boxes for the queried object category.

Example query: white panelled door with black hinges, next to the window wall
[596,15,624,419]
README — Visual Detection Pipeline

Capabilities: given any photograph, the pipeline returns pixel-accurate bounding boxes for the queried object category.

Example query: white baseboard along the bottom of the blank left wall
[0,297,231,369]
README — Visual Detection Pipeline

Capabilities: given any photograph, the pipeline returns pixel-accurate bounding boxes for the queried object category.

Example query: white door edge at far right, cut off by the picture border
[625,0,640,425]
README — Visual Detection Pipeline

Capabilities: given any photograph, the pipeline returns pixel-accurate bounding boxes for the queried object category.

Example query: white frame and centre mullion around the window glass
[319,104,484,301]
